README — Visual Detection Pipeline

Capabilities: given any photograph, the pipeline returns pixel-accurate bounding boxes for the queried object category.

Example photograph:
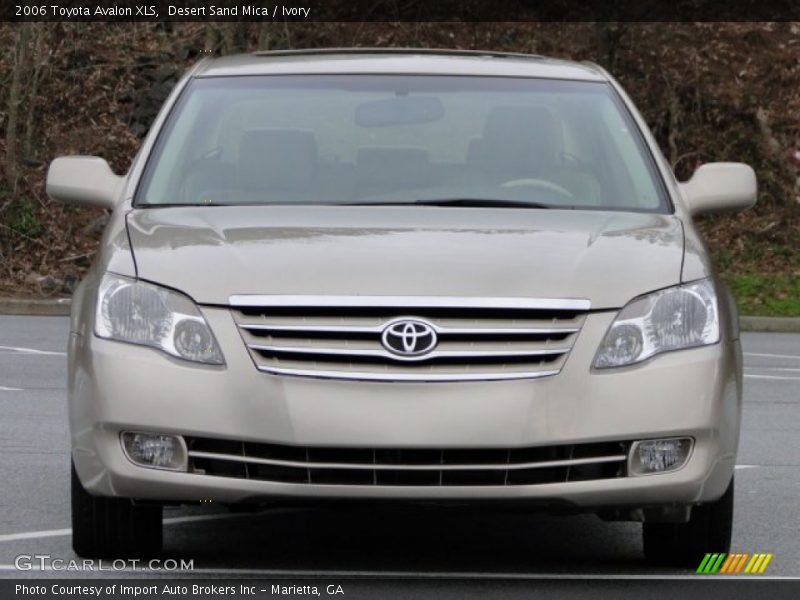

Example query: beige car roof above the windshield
[194,48,607,81]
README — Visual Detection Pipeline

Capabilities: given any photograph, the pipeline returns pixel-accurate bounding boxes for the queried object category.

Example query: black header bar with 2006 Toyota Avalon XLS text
[0,0,800,23]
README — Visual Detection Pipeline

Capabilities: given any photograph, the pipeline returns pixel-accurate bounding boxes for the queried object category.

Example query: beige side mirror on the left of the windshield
[47,156,124,210]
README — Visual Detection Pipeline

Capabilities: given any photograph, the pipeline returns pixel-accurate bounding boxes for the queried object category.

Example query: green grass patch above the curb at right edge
[722,272,800,317]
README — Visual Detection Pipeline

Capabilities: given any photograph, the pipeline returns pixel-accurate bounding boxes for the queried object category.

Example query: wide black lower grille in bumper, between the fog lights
[186,438,630,486]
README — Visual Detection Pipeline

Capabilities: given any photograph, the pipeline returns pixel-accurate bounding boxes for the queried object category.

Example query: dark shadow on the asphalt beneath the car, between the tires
[159,506,681,575]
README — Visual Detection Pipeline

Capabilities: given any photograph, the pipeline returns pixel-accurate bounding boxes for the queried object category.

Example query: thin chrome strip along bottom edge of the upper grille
[257,365,560,382]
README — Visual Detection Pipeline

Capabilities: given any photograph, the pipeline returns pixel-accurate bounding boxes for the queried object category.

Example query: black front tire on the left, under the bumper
[71,464,163,558]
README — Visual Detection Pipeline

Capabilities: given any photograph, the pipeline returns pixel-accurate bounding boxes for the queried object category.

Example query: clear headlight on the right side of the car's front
[594,279,719,369]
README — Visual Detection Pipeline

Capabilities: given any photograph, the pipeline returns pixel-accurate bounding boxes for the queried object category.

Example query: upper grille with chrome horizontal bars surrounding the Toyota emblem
[230,296,589,381]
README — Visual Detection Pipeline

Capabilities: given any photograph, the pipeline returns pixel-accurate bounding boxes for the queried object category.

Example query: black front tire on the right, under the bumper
[642,478,733,568]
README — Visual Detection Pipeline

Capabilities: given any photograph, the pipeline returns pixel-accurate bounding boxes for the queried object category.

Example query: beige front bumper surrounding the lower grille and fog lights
[69,308,741,509]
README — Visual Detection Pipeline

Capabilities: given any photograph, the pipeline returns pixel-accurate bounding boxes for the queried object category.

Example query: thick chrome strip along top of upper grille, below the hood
[228,294,591,310]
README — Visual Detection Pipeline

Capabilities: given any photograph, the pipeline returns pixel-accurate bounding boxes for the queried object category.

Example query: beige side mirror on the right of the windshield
[680,163,758,215]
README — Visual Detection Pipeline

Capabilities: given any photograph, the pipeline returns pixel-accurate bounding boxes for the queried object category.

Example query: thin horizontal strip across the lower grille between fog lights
[189,451,628,471]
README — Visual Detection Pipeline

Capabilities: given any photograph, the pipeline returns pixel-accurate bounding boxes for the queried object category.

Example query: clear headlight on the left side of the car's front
[95,273,225,365]
